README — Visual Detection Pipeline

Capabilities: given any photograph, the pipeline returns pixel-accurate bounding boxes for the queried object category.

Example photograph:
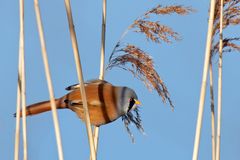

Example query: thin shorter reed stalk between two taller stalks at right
[209,60,216,160]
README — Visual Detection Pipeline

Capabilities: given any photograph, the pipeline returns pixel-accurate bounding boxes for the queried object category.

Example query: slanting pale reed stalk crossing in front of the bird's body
[65,0,96,160]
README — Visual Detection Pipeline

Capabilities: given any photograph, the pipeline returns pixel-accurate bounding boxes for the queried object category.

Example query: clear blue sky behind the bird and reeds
[0,0,240,160]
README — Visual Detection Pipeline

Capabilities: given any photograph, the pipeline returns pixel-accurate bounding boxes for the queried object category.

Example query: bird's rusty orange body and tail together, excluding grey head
[15,82,124,126]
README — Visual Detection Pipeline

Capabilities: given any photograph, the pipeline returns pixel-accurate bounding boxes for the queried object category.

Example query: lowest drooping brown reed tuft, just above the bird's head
[108,45,174,109]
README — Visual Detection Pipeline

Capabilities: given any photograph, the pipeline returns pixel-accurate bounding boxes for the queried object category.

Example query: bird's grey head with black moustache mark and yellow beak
[118,87,140,114]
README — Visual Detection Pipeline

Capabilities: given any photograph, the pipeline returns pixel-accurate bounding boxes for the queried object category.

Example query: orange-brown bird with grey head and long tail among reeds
[14,79,141,127]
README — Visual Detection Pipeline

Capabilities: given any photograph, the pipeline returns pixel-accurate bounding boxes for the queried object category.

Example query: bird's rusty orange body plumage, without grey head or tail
[61,83,122,126]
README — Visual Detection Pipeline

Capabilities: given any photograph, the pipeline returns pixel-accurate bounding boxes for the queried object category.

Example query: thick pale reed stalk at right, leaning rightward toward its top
[192,0,215,160]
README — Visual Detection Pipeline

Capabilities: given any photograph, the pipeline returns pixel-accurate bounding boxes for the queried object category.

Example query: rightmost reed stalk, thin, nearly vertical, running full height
[216,0,224,160]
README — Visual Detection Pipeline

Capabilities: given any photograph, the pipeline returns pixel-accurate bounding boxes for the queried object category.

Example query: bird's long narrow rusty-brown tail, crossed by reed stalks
[14,98,66,117]
